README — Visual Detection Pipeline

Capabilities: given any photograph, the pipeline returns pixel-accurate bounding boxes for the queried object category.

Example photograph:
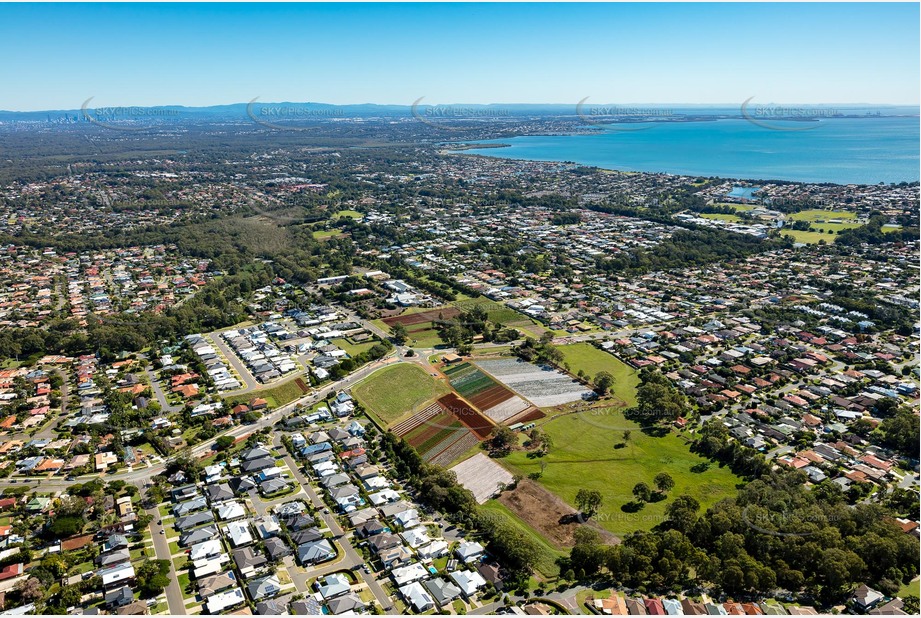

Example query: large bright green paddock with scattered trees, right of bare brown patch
[502,408,739,537]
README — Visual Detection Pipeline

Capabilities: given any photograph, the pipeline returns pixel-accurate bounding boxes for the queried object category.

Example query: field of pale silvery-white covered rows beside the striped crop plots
[477,358,591,408]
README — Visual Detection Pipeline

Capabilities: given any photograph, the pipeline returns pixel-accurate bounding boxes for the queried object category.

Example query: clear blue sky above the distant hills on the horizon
[0,3,921,110]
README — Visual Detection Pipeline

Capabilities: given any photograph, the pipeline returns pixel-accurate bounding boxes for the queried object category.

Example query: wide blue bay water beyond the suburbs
[464,117,921,184]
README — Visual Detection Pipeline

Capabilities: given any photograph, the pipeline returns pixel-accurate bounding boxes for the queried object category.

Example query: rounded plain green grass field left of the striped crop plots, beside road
[352,363,449,425]
